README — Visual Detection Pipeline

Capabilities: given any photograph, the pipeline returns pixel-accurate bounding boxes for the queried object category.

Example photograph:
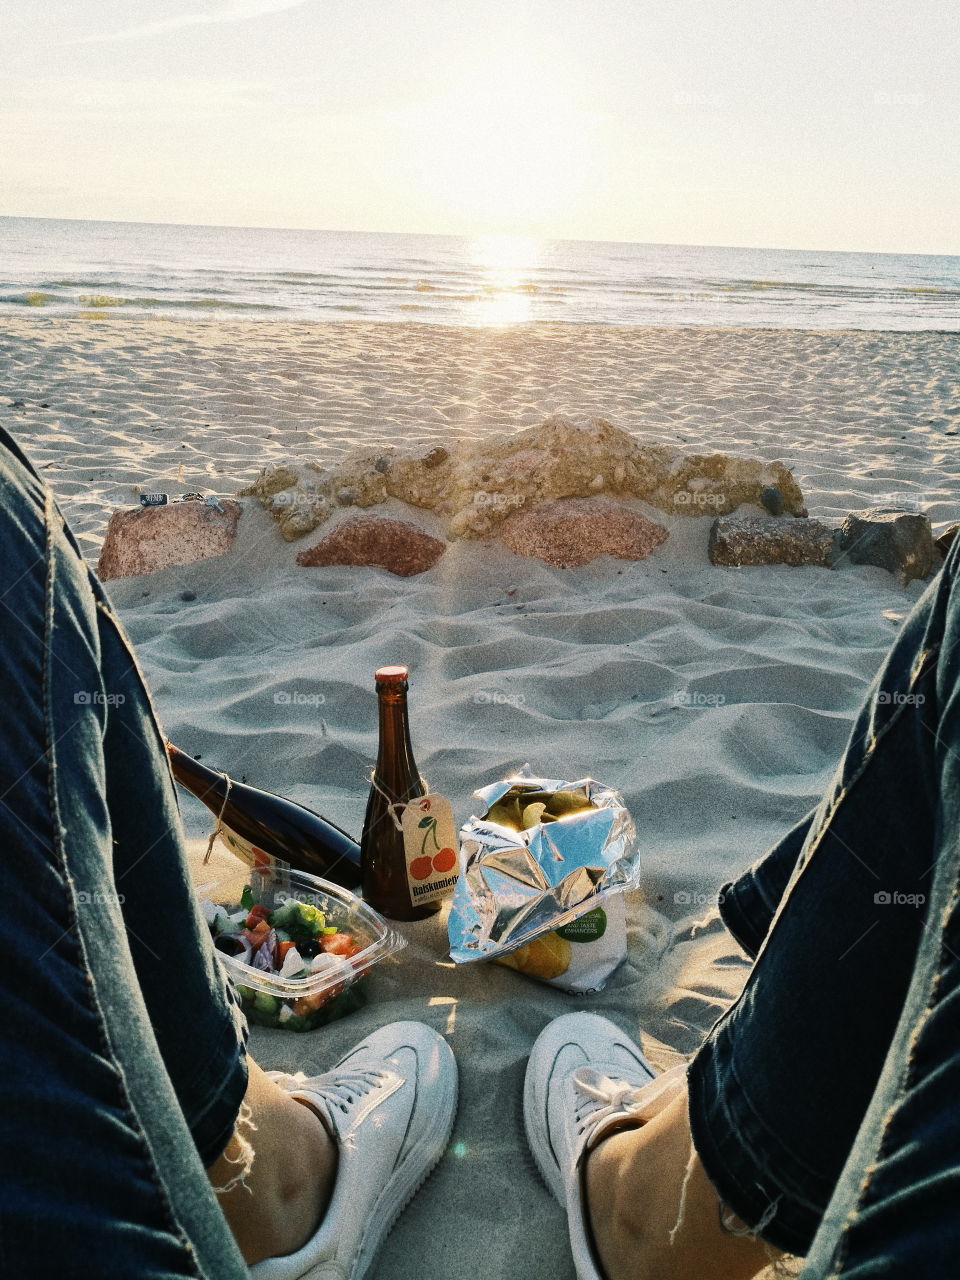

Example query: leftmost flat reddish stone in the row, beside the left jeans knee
[97,498,243,581]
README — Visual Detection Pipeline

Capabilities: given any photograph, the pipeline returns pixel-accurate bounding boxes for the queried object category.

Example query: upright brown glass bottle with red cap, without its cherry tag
[360,667,440,920]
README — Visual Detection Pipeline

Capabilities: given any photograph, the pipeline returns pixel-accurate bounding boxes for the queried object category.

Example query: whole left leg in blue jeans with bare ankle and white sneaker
[0,431,457,1280]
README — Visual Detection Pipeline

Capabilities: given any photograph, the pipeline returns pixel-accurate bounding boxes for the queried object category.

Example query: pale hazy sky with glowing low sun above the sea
[0,0,960,253]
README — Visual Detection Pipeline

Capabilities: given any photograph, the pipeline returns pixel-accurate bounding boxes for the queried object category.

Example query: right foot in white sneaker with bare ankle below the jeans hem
[524,1014,771,1280]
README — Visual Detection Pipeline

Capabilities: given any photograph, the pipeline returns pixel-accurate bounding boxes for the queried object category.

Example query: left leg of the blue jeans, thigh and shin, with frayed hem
[0,431,247,1280]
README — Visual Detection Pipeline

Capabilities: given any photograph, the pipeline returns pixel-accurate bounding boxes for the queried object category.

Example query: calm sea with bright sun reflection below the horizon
[0,218,960,332]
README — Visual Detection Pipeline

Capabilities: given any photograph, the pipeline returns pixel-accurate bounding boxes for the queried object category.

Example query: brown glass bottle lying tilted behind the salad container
[166,742,360,890]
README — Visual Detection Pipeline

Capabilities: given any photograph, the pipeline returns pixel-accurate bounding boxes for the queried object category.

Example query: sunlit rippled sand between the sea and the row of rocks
[0,316,960,547]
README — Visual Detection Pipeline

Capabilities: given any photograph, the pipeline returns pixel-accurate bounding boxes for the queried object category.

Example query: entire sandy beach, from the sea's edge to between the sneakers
[0,316,960,1280]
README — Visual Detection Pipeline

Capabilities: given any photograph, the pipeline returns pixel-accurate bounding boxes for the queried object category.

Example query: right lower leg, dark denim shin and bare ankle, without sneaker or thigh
[529,535,960,1280]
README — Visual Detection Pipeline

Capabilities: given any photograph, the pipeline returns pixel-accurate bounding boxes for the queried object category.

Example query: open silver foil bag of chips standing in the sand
[448,768,640,992]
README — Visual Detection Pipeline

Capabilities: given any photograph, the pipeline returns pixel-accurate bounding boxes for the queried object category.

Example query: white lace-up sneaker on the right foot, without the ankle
[524,1014,682,1280]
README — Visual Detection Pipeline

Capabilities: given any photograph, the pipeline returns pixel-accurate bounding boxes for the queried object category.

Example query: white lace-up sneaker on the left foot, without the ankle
[250,1023,457,1280]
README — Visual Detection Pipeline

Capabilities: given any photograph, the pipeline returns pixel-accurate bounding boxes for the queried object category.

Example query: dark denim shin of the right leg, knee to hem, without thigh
[687,532,960,1254]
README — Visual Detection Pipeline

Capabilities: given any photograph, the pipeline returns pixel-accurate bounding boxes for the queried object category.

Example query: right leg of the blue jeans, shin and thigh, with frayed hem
[689,527,960,1259]
